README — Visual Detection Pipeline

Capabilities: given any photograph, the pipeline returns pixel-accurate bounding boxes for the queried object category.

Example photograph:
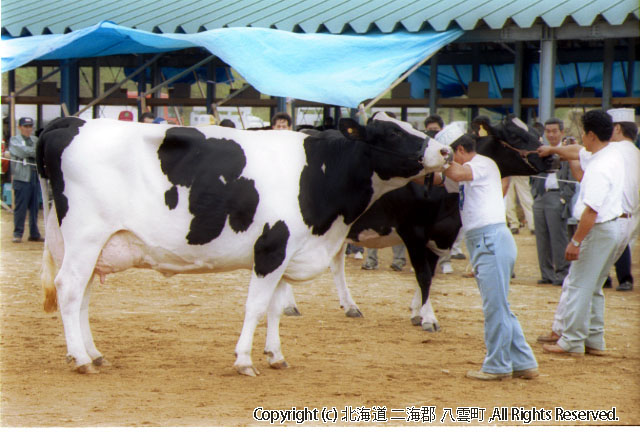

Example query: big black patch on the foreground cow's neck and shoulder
[298,130,373,235]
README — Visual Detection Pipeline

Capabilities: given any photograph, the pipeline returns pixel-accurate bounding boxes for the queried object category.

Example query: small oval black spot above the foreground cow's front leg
[253,220,289,277]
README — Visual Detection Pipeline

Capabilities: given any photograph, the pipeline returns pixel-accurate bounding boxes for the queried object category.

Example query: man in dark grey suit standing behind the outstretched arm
[531,118,576,286]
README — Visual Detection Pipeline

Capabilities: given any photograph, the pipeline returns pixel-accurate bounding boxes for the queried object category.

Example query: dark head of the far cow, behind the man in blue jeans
[472,115,554,177]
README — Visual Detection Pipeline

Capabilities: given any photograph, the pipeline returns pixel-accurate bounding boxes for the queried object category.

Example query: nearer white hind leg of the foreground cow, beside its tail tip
[55,257,97,374]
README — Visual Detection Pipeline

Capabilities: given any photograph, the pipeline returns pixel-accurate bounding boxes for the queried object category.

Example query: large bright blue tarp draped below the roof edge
[0,21,463,108]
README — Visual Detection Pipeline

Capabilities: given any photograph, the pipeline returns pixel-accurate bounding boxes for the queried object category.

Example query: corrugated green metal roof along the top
[1,0,640,37]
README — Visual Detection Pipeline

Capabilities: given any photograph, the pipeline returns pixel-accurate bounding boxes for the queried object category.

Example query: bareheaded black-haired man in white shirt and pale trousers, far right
[539,110,625,356]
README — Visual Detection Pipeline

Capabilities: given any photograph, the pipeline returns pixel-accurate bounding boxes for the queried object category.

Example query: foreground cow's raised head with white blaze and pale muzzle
[339,112,453,180]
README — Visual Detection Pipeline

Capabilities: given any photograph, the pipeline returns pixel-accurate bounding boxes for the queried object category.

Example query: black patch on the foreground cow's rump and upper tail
[36,117,86,224]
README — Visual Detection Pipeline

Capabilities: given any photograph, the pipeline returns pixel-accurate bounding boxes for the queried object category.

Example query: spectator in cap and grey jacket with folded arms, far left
[9,117,44,243]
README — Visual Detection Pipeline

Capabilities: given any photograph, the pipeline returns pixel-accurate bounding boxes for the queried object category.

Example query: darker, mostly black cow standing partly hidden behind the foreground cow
[320,115,554,331]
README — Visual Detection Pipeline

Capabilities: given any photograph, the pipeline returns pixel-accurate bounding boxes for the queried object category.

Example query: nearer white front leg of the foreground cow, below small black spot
[234,272,282,377]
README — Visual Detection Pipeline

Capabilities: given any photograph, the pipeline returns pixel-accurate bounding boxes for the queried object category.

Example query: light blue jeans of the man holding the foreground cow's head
[465,223,538,374]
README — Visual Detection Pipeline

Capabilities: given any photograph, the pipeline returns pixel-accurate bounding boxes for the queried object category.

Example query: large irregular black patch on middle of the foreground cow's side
[158,127,259,245]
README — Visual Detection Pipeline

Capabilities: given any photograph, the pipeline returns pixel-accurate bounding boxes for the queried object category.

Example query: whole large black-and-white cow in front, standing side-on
[36,114,452,376]
